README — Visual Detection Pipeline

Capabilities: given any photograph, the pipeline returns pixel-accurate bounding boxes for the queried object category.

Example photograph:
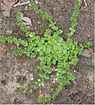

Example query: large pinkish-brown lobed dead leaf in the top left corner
[1,0,18,17]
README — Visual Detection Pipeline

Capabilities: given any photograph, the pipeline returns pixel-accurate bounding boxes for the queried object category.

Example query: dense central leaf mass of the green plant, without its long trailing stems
[15,12,83,85]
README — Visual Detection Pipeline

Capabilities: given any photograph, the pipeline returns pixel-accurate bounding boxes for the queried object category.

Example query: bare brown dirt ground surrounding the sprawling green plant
[0,0,94,104]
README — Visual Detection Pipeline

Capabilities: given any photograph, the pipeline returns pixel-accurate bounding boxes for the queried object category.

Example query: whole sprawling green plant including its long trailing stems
[0,0,89,103]
